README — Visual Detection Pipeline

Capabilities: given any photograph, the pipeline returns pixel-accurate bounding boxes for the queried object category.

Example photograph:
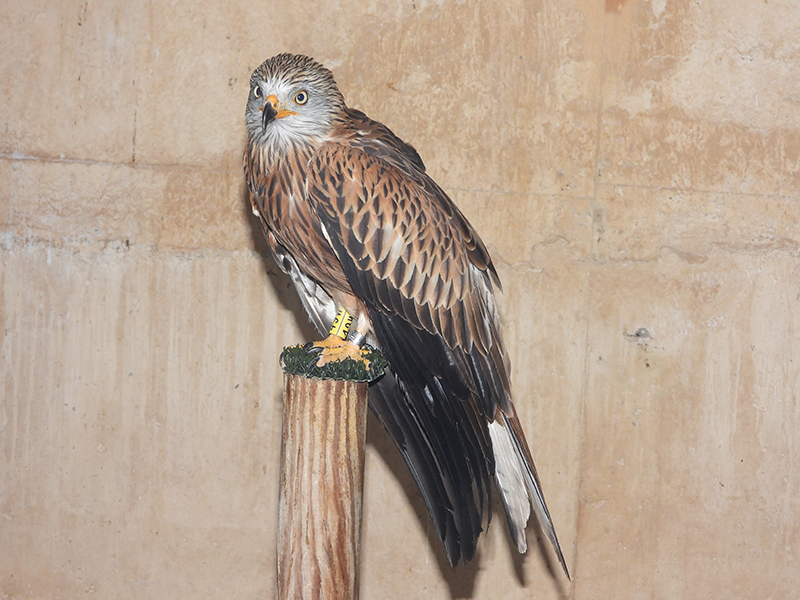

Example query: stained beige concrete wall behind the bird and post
[0,0,800,600]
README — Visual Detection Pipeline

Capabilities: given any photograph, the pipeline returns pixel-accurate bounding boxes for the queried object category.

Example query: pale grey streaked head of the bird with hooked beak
[245,54,344,151]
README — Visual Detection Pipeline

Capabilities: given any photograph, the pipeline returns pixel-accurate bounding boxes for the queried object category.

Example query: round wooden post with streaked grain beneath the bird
[278,346,385,600]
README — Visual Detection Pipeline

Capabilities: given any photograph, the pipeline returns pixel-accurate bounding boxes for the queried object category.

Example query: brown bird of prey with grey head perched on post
[244,54,569,577]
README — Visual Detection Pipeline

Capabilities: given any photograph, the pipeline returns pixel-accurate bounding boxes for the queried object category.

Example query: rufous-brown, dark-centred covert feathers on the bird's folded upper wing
[308,122,497,353]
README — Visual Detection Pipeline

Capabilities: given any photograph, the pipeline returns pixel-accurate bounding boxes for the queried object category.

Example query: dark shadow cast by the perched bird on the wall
[241,184,567,599]
